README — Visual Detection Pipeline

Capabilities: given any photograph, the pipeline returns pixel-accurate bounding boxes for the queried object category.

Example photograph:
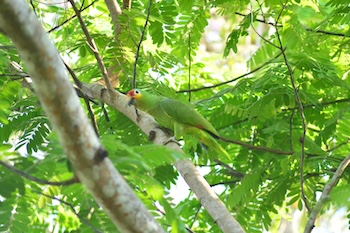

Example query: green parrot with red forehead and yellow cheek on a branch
[127,89,230,158]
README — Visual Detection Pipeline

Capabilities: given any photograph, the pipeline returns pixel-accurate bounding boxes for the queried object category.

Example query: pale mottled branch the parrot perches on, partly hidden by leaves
[83,83,244,233]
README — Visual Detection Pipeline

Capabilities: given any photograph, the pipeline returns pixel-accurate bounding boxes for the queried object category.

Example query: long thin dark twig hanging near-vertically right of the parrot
[275,0,311,212]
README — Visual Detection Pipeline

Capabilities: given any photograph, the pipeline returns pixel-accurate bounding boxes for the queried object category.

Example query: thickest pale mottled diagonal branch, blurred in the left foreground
[0,0,164,233]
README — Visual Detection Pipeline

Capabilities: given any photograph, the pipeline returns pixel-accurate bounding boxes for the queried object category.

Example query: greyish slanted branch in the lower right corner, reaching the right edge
[304,154,350,233]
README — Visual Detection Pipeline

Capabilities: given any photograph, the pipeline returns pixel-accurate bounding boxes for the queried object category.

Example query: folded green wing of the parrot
[159,98,218,136]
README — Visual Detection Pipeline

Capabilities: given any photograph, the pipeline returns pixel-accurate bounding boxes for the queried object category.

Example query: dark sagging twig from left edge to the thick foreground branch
[0,160,79,186]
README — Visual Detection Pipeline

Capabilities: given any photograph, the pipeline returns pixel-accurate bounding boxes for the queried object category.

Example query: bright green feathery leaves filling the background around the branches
[0,0,350,232]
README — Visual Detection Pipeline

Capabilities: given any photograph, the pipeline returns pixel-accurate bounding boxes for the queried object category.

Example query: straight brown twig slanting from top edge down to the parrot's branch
[68,0,113,93]
